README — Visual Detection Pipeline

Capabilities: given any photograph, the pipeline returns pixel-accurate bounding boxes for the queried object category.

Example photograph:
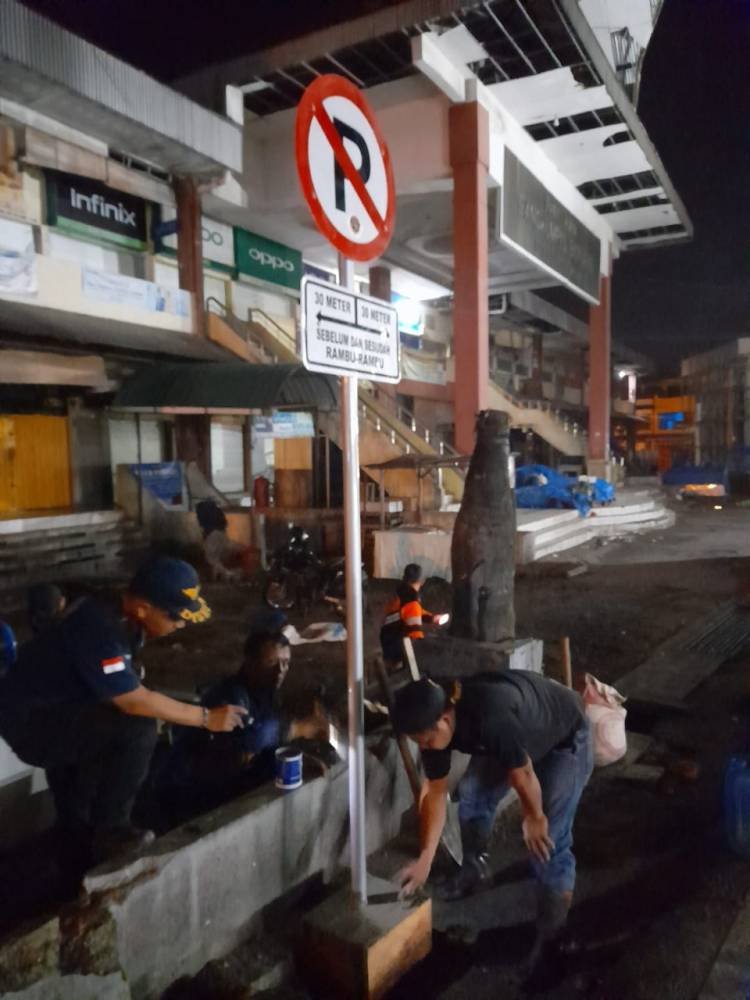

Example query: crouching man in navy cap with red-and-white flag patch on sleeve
[0,557,246,861]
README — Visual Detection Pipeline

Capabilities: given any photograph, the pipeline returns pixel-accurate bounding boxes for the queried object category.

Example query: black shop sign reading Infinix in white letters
[47,172,148,250]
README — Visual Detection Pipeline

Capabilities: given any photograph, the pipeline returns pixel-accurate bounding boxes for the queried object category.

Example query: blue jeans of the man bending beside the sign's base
[458,720,594,893]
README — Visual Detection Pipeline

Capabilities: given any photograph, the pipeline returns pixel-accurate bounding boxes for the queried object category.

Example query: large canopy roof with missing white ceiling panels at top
[181,0,692,250]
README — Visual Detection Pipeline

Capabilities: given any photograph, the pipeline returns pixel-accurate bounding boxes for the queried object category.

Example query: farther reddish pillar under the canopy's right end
[587,268,612,480]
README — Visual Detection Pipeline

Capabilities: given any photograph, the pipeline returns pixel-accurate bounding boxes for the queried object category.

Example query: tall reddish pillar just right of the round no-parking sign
[449,102,490,453]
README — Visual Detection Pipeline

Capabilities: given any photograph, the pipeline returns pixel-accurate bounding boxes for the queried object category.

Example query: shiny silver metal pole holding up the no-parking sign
[339,254,367,903]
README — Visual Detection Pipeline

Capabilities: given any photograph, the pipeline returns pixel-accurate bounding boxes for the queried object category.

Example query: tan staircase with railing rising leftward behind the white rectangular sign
[208,299,464,501]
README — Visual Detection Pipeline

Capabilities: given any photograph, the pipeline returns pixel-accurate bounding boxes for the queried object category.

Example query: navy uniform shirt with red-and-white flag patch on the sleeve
[0,598,143,711]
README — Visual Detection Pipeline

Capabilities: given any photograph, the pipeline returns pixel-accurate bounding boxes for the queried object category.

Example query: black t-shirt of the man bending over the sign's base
[422,670,584,781]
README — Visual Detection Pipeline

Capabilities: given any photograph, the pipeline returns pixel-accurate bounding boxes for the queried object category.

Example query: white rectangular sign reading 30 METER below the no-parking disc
[302,278,401,383]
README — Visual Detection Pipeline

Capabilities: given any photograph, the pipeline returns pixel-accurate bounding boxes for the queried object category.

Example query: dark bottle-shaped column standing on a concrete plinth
[451,410,516,642]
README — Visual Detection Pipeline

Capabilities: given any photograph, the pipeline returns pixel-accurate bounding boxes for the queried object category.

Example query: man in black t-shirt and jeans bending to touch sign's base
[391,670,593,976]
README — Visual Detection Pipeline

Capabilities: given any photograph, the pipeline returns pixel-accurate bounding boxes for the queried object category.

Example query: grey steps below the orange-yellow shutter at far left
[0,510,148,609]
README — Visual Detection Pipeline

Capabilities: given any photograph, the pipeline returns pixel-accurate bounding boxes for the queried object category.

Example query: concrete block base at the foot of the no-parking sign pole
[297,877,432,1000]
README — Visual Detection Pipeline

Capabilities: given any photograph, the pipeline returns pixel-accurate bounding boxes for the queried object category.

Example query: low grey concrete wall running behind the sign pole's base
[0,735,413,1000]
